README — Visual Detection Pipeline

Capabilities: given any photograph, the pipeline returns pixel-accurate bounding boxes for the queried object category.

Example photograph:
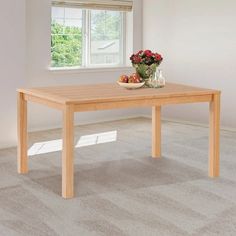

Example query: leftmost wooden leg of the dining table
[17,92,28,174]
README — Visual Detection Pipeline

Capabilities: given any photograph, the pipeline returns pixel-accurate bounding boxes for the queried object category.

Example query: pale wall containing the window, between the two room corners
[27,0,142,133]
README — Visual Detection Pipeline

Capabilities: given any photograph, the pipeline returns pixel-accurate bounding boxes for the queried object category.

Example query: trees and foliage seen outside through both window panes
[51,11,121,67]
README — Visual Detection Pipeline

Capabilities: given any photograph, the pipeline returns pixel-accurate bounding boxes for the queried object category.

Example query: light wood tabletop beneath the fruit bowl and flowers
[18,83,218,104]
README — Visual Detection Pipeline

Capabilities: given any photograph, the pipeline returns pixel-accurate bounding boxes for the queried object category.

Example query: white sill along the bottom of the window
[48,66,133,74]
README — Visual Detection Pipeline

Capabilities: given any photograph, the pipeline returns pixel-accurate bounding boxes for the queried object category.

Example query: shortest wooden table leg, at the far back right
[152,106,161,158]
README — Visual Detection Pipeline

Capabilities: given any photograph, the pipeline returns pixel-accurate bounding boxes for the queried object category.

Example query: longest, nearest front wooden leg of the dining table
[62,105,74,198]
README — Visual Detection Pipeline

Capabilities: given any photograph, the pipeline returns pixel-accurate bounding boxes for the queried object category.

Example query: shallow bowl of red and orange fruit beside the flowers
[117,73,144,89]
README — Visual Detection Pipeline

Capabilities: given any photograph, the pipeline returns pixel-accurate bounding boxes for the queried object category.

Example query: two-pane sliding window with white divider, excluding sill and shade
[51,6,125,67]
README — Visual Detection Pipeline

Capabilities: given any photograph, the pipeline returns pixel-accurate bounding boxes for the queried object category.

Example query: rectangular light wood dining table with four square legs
[17,83,221,198]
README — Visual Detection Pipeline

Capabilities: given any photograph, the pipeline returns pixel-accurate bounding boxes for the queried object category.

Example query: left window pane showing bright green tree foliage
[51,7,84,67]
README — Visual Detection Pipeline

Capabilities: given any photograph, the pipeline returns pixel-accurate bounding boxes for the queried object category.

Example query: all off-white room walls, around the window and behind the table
[0,0,236,148]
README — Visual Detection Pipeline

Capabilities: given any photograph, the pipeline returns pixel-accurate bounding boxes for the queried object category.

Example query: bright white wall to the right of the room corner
[143,0,236,128]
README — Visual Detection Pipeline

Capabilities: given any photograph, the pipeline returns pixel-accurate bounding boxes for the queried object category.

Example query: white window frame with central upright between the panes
[49,6,126,71]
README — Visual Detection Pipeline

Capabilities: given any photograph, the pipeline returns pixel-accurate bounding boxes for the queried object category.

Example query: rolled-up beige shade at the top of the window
[52,0,133,11]
